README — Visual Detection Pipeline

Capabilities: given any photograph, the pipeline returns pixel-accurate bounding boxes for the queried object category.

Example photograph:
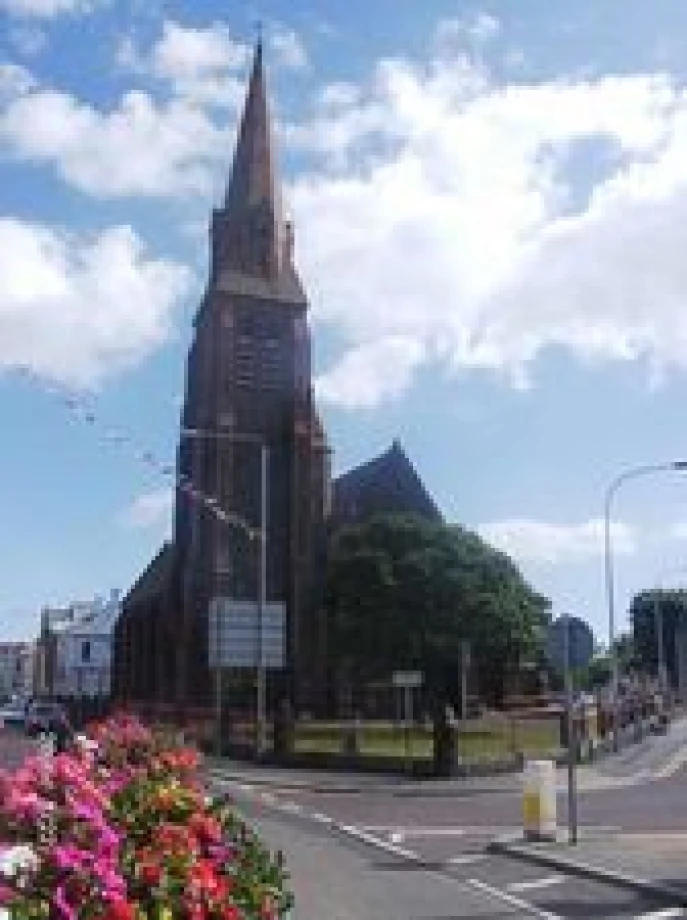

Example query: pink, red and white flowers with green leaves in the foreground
[0,716,292,920]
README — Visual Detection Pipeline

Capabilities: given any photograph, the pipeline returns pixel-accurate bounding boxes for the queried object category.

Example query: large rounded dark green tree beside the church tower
[326,516,549,702]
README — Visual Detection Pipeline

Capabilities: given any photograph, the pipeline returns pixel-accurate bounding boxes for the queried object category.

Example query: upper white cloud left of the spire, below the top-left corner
[0,70,226,198]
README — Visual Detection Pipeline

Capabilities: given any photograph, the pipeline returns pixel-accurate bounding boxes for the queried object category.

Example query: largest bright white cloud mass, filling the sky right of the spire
[285,41,687,398]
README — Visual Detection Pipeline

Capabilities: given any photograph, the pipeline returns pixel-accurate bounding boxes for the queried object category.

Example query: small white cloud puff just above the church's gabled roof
[315,336,425,409]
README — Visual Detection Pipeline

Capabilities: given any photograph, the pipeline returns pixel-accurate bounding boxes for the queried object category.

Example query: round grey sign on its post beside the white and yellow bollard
[548,614,594,844]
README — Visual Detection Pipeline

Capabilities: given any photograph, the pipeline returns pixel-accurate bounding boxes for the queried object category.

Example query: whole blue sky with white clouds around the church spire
[5,0,687,637]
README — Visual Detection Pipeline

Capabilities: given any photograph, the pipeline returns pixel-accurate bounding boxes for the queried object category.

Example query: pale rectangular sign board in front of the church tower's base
[208,597,286,670]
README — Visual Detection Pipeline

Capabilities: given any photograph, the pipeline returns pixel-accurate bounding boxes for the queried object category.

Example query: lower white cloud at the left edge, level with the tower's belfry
[0,218,190,387]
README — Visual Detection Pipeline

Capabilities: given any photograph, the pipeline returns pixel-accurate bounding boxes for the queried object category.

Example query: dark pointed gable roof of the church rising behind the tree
[330,441,443,530]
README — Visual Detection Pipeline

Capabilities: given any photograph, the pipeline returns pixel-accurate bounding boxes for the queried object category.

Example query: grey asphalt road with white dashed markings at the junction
[208,776,687,920]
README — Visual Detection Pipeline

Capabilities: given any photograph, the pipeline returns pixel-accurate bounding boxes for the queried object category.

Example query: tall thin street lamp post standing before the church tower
[181,428,269,756]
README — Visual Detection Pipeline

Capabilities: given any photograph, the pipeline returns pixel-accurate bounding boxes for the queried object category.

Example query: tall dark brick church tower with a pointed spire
[115,44,330,712]
